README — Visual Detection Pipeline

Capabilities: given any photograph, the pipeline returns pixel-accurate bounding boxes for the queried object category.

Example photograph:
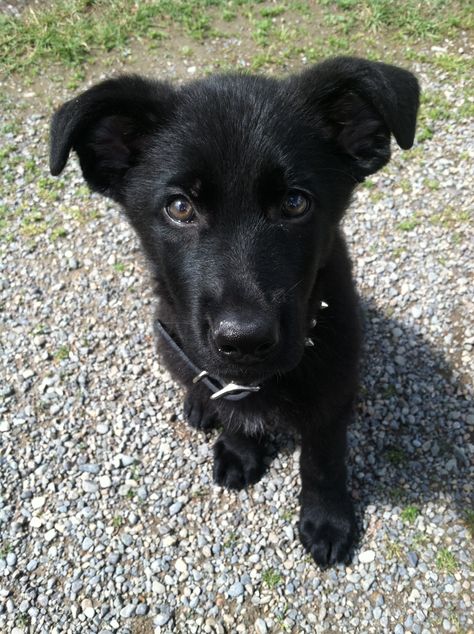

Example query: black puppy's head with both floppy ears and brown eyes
[51,58,419,381]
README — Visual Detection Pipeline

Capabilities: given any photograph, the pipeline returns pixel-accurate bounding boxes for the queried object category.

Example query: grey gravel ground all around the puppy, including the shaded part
[0,53,474,634]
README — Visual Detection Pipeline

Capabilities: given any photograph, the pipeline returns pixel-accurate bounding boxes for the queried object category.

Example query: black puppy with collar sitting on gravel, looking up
[51,57,419,566]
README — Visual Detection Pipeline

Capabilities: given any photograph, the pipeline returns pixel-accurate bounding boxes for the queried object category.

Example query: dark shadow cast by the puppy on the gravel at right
[270,301,474,530]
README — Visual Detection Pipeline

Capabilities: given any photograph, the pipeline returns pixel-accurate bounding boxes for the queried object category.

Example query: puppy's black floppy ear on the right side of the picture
[297,57,420,180]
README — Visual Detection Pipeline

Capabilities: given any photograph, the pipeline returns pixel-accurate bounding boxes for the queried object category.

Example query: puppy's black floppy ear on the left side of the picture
[50,75,174,202]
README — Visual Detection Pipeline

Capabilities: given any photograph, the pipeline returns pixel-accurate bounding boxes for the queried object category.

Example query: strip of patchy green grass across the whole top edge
[0,0,473,81]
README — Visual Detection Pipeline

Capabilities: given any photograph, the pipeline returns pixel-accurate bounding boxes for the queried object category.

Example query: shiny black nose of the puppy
[212,315,278,361]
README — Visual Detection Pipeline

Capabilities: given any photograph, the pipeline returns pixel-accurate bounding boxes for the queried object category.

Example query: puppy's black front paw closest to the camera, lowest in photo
[299,497,356,568]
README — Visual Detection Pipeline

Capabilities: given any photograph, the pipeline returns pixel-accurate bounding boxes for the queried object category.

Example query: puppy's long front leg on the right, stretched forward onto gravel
[299,412,356,567]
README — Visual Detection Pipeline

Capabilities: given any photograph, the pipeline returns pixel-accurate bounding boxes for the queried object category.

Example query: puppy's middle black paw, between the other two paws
[214,432,265,490]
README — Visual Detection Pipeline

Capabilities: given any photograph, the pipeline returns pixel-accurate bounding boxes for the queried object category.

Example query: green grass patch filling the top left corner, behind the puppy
[0,0,220,75]
